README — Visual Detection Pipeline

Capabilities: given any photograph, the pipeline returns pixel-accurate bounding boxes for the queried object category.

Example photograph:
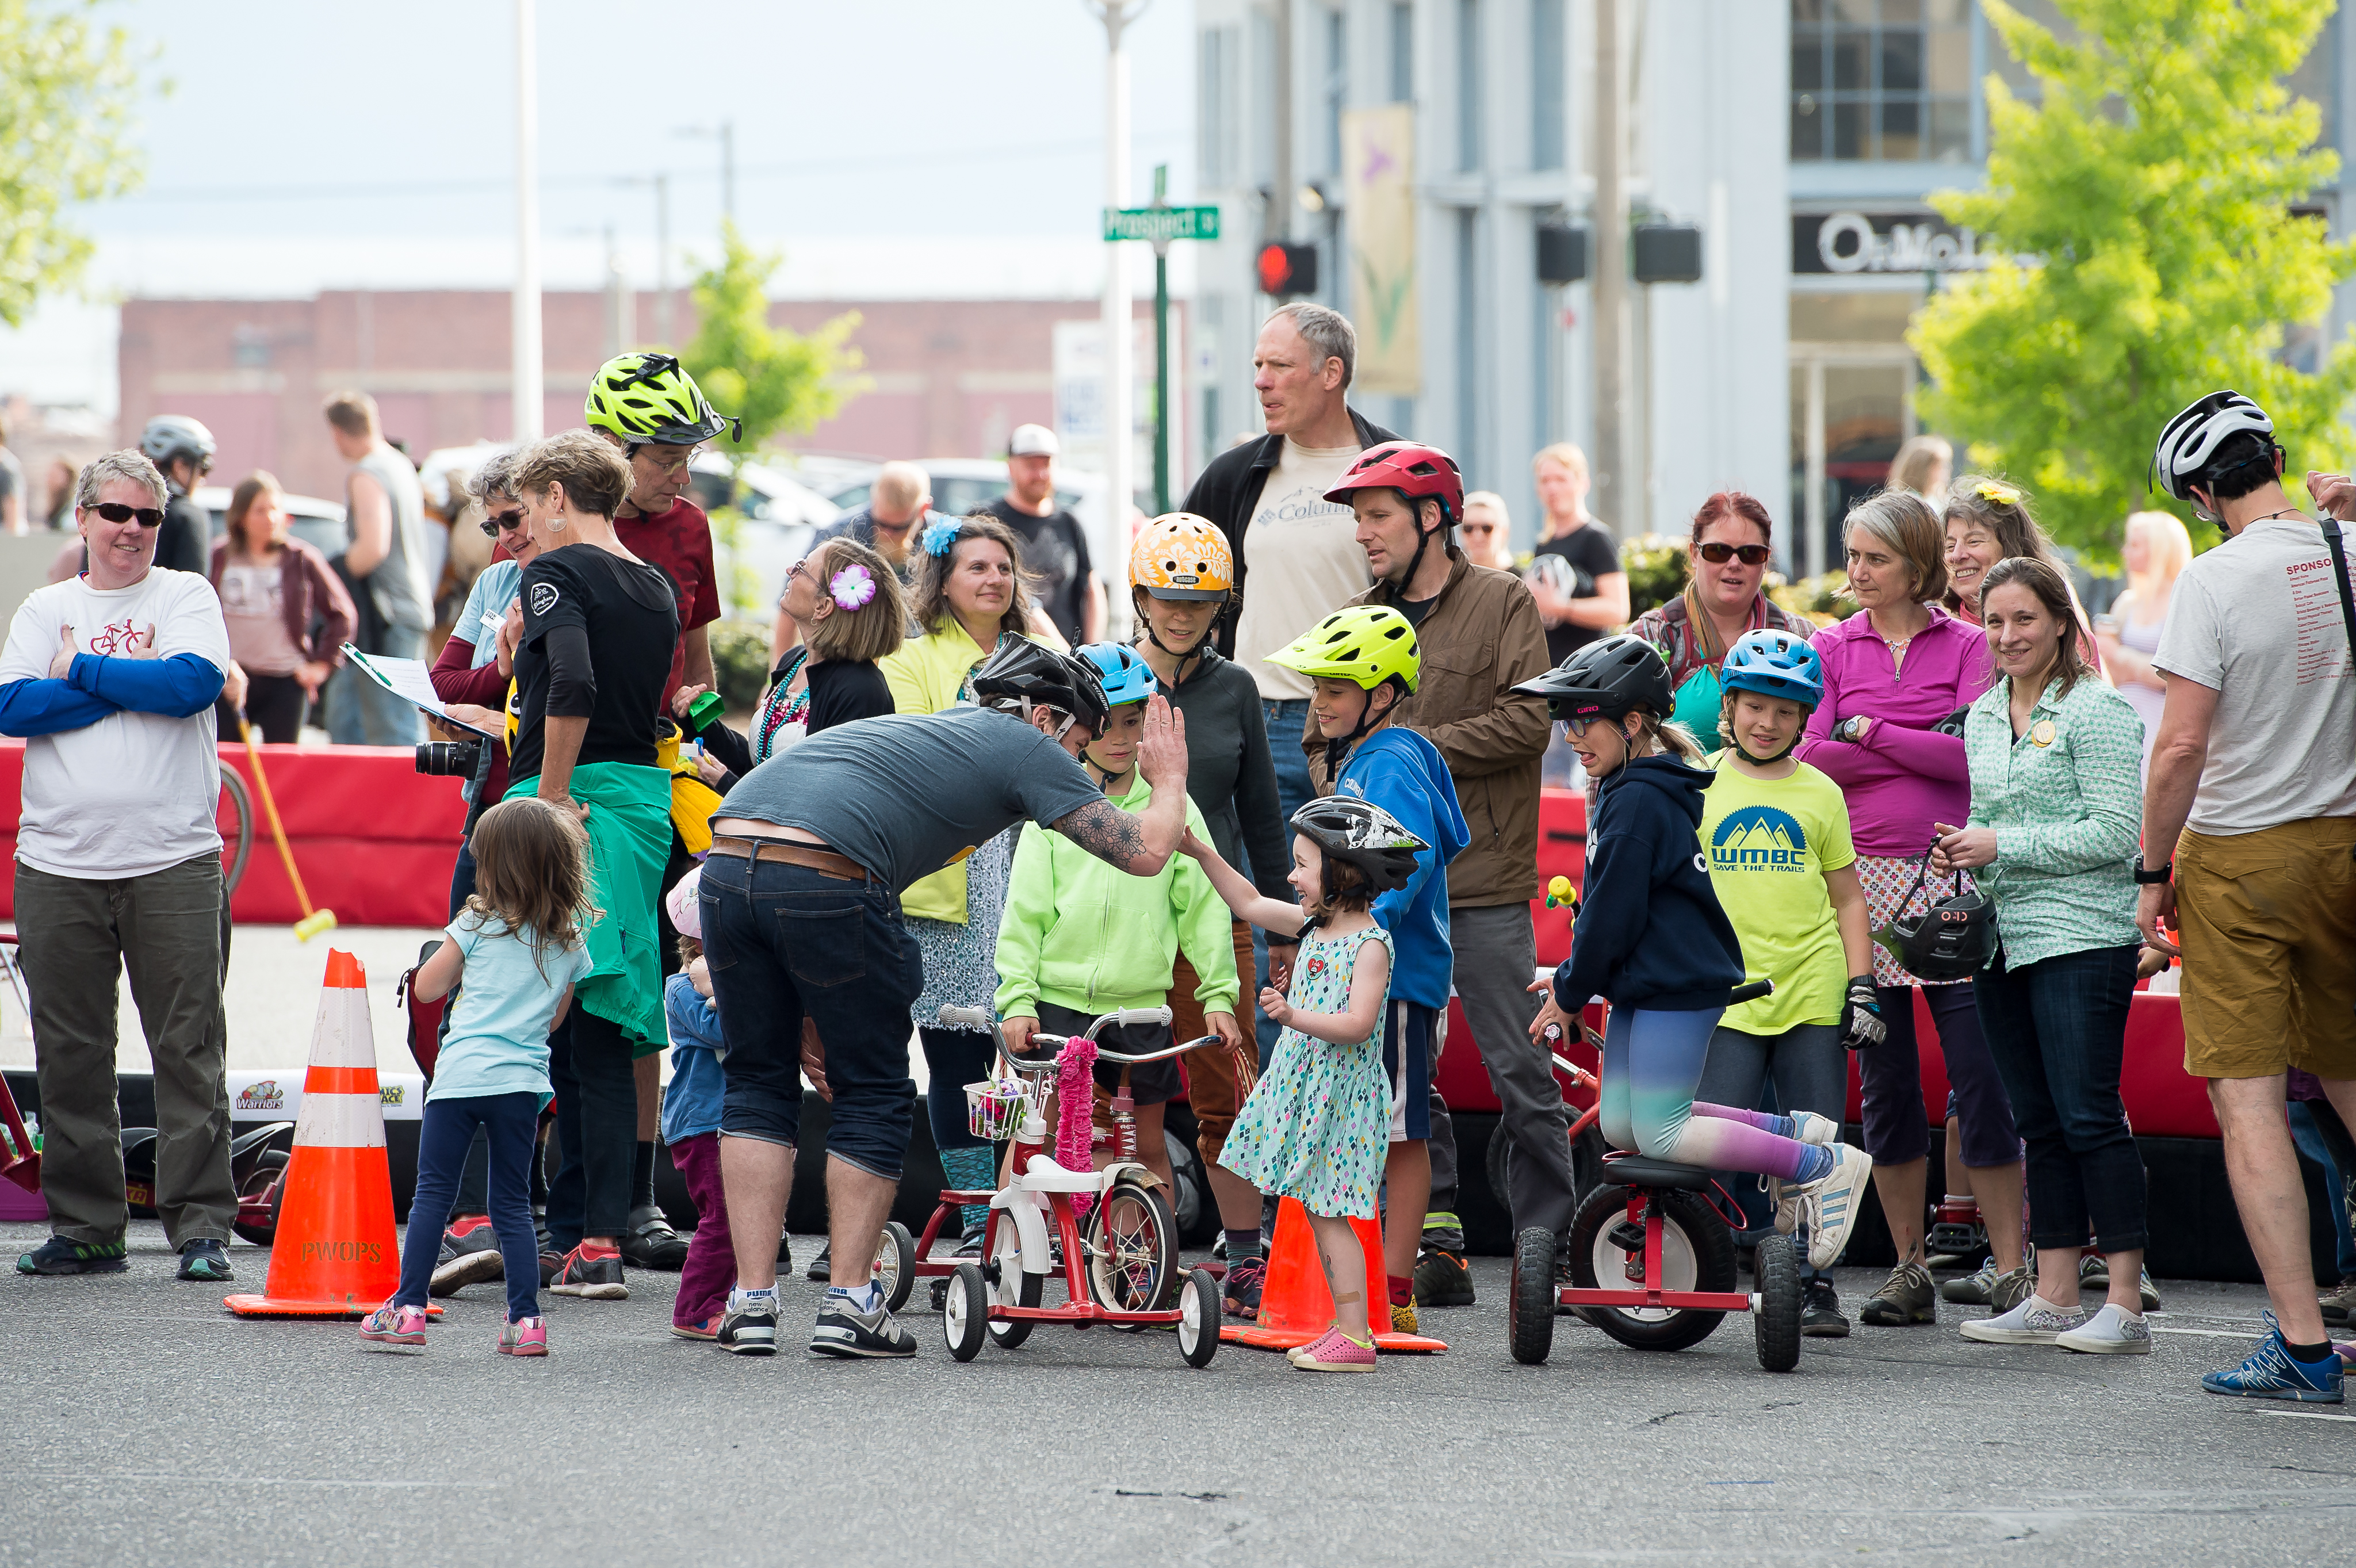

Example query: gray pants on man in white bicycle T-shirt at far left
[17,855,238,1248]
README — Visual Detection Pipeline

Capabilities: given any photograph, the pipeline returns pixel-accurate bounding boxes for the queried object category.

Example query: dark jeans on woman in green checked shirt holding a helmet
[1972,944,2144,1253]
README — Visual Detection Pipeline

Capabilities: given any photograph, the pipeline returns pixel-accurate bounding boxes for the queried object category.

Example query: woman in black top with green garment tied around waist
[507,431,679,1299]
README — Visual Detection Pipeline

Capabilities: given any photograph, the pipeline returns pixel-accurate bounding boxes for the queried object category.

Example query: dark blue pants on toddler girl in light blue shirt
[393,1090,540,1323]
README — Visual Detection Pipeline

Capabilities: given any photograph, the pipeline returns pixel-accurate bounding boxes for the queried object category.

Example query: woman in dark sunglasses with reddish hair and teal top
[1628,489,1816,744]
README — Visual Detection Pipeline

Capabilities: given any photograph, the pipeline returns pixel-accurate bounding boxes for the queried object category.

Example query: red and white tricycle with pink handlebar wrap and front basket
[916,1008,1218,1366]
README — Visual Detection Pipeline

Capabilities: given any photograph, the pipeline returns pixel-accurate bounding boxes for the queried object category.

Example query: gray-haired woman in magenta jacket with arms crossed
[1797,489,2029,1325]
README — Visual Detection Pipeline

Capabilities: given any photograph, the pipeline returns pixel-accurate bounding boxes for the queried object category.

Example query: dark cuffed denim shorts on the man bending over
[700,855,924,1182]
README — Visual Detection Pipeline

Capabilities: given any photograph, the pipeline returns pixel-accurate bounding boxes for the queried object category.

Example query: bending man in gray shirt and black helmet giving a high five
[700,640,1187,1359]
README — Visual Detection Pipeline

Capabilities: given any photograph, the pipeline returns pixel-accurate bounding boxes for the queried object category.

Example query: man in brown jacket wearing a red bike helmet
[1303,440,1571,1307]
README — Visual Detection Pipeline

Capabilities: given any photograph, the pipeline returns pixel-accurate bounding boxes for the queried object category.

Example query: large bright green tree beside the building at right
[1908,0,2356,556]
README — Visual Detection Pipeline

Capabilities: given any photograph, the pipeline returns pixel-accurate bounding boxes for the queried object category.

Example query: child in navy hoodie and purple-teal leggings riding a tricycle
[1515,636,1873,1269]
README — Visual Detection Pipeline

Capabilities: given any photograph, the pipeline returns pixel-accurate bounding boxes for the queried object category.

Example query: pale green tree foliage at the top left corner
[0,0,141,327]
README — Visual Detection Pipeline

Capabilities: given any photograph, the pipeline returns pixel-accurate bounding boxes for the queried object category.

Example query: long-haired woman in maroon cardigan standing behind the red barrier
[207,471,355,747]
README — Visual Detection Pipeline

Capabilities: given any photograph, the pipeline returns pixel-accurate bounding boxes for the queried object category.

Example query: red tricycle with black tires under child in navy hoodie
[1508,980,1800,1372]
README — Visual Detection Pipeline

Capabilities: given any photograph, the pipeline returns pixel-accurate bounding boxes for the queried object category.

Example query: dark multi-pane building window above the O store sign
[1791,0,1972,162]
